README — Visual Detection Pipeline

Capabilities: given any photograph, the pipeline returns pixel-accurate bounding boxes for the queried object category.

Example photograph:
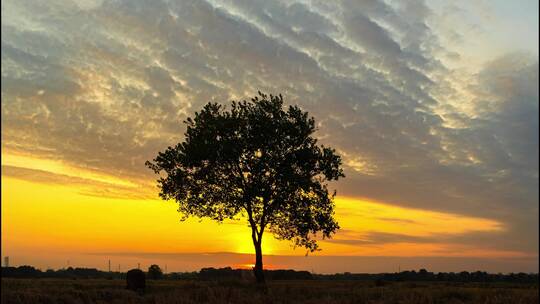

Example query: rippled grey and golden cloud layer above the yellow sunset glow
[1,0,539,254]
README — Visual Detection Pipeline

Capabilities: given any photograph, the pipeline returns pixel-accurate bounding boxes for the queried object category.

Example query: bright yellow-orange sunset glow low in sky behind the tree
[2,154,522,268]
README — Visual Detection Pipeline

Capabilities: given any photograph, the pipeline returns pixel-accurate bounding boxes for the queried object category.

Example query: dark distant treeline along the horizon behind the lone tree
[2,266,538,283]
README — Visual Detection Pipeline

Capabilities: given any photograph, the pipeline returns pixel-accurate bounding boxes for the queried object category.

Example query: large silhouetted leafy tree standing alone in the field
[146,92,344,282]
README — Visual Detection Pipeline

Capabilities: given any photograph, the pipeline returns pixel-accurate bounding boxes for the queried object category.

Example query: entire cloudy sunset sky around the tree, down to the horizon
[1,0,539,273]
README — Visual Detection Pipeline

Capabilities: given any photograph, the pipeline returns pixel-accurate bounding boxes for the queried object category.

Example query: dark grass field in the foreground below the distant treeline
[2,278,538,304]
